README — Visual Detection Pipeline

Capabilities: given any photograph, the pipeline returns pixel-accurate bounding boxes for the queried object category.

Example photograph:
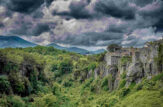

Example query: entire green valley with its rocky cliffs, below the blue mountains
[0,40,163,107]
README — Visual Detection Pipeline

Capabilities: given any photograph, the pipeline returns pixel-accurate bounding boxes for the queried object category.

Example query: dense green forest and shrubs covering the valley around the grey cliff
[0,46,163,107]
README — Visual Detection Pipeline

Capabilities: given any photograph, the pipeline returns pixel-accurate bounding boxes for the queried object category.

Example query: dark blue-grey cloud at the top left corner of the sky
[1,0,44,13]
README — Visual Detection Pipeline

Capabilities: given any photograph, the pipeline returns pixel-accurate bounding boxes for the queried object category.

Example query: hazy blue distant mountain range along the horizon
[0,36,105,55]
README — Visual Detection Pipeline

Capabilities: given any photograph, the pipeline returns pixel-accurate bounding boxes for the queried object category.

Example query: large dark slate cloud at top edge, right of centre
[95,0,135,19]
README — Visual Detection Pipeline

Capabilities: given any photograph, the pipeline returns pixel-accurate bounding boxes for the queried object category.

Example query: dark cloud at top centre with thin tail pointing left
[52,0,92,19]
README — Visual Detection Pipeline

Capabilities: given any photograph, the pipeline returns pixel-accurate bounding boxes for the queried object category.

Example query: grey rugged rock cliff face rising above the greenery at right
[87,40,163,90]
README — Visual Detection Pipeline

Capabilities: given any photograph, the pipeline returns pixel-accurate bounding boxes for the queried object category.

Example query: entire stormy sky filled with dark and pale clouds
[0,0,163,49]
